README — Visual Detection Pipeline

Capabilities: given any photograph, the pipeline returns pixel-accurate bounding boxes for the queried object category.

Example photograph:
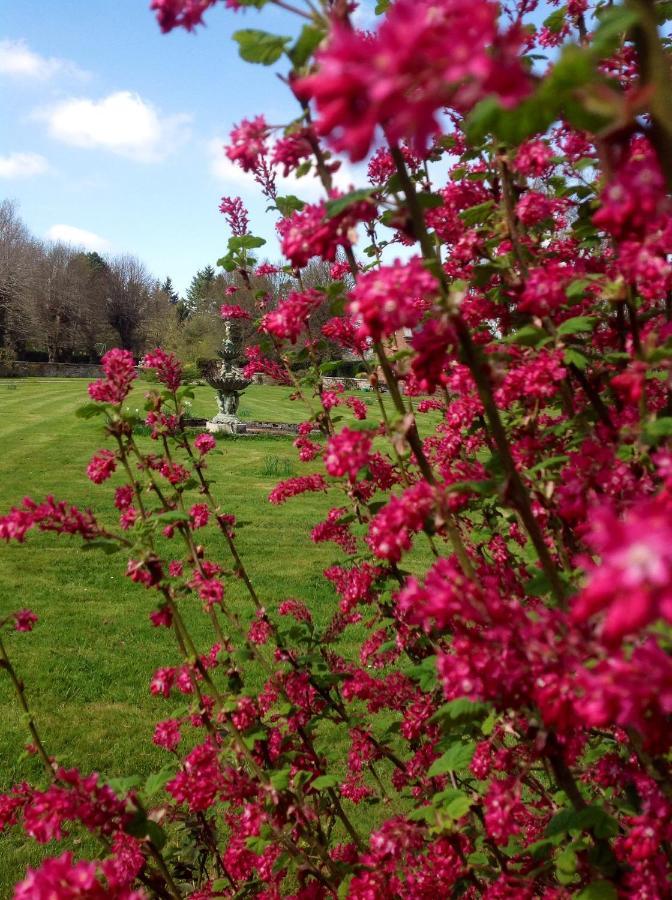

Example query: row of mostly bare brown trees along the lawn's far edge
[0,200,350,362]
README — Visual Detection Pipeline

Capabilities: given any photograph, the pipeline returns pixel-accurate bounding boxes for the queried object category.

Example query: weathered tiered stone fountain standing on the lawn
[200,318,252,434]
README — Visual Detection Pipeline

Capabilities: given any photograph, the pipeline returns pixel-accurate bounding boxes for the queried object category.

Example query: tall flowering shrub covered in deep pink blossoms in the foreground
[0,0,672,900]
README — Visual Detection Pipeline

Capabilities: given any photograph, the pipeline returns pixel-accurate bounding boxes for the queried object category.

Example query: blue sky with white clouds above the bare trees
[0,0,376,290]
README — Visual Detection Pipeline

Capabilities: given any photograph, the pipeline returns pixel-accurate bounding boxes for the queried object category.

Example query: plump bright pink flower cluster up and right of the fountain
[348,257,439,341]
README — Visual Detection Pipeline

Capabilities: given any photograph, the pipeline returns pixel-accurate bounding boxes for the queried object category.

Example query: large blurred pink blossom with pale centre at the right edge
[573,495,672,643]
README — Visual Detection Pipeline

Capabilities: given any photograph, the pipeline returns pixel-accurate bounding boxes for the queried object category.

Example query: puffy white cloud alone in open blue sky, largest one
[35,91,190,162]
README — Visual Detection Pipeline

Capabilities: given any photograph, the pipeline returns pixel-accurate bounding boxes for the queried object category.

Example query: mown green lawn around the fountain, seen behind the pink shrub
[0,379,420,898]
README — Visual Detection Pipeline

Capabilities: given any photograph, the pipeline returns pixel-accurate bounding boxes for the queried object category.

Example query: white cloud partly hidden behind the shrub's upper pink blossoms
[207,138,368,203]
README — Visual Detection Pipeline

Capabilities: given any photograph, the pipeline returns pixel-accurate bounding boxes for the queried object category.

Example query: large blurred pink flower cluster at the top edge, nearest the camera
[294,0,530,161]
